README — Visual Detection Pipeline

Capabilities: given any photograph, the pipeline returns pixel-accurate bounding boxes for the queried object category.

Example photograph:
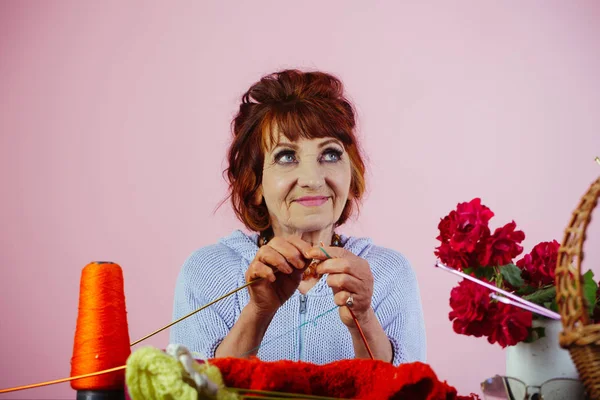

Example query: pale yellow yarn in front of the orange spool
[125,347,239,400]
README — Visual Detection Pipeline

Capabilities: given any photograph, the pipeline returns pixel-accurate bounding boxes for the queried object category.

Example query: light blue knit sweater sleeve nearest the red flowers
[370,247,427,365]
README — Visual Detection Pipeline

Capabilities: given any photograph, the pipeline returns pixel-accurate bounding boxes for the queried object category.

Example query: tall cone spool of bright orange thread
[71,262,131,390]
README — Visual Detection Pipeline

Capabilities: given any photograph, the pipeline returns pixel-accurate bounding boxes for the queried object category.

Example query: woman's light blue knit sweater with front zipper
[170,231,426,365]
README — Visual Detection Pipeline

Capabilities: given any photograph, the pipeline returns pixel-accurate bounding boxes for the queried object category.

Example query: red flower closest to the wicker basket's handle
[517,240,560,287]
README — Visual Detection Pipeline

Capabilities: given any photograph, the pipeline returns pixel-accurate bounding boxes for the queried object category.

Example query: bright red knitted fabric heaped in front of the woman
[209,358,479,400]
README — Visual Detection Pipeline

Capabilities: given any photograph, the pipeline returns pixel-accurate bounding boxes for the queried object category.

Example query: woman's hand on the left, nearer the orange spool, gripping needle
[246,237,311,315]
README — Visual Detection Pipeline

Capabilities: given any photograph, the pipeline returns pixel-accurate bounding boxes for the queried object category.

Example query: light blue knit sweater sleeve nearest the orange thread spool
[169,244,240,358]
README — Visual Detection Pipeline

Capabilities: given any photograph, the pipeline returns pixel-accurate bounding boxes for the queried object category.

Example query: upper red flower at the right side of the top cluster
[478,221,525,266]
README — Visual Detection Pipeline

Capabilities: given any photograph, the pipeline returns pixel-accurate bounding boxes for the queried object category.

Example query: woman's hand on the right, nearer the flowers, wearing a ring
[306,247,375,329]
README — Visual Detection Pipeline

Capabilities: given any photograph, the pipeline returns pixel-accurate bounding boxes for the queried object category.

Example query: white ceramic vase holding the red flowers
[506,320,583,399]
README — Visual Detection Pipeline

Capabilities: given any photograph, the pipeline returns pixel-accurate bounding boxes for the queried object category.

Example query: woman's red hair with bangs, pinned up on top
[226,70,365,231]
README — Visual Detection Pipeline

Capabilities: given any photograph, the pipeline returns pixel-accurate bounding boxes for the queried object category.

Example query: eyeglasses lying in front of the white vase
[481,375,587,400]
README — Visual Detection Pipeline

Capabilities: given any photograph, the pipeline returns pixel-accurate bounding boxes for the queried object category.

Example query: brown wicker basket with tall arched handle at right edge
[556,178,600,399]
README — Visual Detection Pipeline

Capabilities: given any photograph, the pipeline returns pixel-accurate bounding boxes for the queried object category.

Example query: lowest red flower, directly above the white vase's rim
[488,303,533,348]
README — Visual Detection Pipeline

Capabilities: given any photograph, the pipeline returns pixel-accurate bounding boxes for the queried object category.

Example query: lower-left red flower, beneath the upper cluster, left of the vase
[448,279,492,337]
